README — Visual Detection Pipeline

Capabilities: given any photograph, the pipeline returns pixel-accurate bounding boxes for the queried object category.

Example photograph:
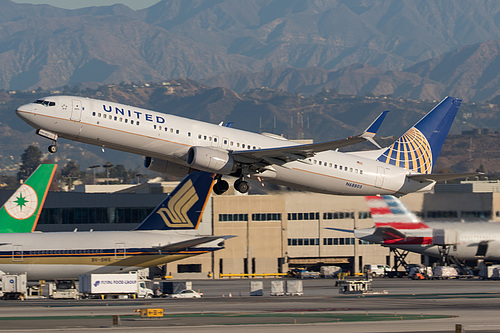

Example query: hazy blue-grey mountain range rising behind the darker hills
[0,0,500,102]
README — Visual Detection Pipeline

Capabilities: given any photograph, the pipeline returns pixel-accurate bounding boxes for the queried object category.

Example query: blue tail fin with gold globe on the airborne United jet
[377,97,462,174]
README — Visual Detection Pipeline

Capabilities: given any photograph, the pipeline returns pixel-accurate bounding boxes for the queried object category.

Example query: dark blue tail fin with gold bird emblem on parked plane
[135,171,215,230]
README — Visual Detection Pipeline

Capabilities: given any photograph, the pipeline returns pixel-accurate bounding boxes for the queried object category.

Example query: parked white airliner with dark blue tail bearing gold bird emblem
[0,171,231,280]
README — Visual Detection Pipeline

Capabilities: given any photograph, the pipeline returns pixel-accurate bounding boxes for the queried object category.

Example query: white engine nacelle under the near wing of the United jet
[186,147,235,175]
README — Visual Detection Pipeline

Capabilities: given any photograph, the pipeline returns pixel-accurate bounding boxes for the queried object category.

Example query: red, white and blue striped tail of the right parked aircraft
[354,195,432,245]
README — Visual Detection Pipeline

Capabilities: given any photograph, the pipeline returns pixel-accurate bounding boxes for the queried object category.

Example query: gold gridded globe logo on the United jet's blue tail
[378,127,433,174]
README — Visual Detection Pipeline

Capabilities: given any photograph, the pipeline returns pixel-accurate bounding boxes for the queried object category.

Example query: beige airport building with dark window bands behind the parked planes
[0,181,500,279]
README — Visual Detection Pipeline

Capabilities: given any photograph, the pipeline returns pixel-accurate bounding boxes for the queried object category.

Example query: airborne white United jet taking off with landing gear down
[16,96,472,196]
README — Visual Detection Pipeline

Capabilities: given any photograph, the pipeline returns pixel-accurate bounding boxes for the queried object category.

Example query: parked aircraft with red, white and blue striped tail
[354,195,500,261]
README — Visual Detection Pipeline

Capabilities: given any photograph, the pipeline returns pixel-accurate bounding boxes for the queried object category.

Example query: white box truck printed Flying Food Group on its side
[79,273,153,298]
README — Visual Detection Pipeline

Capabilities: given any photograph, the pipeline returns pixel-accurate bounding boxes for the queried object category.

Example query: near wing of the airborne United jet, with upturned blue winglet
[232,111,389,165]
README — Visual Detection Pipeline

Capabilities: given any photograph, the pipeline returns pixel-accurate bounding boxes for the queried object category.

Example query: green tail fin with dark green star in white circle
[0,164,57,233]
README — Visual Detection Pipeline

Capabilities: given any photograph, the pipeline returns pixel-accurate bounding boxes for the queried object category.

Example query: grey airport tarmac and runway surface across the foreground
[0,278,500,333]
